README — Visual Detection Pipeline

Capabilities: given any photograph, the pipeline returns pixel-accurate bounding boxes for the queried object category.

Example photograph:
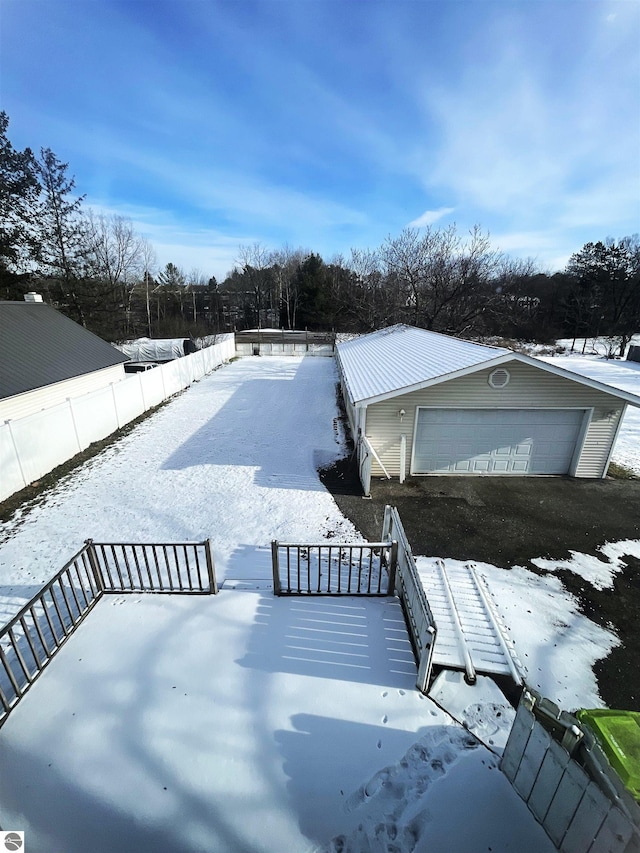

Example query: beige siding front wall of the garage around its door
[366,362,624,477]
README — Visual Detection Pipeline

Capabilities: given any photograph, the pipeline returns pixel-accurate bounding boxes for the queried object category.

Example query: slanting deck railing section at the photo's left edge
[0,546,102,725]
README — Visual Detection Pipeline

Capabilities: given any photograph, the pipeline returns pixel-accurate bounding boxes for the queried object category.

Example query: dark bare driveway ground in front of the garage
[322,460,640,711]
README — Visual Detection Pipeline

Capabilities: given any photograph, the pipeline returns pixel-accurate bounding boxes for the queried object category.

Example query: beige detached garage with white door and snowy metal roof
[336,325,640,493]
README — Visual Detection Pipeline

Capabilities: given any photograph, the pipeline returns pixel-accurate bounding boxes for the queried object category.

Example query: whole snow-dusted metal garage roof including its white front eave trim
[337,324,640,408]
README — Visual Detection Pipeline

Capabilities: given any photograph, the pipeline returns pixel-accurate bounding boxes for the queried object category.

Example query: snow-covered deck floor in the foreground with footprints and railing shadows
[0,583,551,853]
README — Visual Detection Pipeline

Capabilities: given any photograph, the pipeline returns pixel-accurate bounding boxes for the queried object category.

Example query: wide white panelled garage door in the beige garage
[413,409,584,474]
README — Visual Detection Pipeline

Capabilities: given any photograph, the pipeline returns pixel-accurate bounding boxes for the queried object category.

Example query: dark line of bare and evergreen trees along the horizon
[0,113,640,352]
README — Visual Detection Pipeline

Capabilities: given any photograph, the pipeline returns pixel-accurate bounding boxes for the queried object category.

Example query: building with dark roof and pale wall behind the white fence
[0,293,128,423]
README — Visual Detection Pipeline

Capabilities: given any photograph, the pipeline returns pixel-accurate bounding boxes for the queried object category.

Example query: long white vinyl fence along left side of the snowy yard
[0,334,235,501]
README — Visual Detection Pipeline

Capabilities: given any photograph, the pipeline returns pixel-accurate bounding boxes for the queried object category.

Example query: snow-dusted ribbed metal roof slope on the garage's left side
[337,324,512,403]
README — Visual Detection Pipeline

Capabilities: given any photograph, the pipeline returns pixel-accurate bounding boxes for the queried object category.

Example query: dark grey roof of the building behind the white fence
[0,301,128,398]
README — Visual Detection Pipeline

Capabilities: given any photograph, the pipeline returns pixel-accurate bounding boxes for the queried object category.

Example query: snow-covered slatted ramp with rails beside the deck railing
[419,560,523,685]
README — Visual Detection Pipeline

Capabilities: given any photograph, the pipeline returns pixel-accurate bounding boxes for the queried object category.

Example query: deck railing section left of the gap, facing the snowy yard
[87,539,218,595]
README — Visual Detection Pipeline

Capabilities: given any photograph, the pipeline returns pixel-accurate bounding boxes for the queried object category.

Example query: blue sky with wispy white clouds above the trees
[0,0,640,280]
